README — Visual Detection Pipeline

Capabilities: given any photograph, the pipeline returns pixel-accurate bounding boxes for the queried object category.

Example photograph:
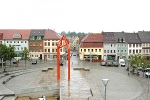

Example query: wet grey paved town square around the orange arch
[0,52,150,100]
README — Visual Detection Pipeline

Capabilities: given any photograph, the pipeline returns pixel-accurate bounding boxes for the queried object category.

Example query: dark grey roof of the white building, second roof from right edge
[125,33,142,43]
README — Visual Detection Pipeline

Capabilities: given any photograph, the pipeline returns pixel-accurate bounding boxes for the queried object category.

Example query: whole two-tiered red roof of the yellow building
[80,33,103,48]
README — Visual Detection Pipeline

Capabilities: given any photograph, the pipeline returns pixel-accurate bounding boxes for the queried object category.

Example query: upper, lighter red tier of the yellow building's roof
[81,33,103,42]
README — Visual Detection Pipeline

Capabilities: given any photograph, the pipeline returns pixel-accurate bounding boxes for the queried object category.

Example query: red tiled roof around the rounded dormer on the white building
[3,29,31,40]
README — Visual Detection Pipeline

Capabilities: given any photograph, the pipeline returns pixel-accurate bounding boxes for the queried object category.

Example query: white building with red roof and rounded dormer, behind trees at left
[3,29,31,59]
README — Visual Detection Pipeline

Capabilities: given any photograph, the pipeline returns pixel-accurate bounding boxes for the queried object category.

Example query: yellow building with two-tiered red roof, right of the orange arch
[79,33,104,61]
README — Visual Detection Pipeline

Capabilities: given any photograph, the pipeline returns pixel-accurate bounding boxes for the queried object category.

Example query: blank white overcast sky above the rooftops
[0,0,150,33]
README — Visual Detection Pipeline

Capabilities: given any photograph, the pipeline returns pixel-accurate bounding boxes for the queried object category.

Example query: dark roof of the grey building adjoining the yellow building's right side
[102,32,117,43]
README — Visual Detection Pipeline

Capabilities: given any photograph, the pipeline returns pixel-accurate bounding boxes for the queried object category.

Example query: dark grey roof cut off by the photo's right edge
[138,31,150,43]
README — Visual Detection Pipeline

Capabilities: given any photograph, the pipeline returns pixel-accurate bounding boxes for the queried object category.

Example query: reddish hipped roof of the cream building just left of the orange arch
[43,29,61,40]
